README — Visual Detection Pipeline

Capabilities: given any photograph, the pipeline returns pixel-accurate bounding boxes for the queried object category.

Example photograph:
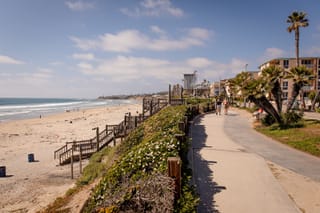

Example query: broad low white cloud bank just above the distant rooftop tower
[78,56,247,84]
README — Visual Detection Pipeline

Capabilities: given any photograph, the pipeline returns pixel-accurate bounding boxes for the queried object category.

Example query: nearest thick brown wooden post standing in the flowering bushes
[168,157,181,199]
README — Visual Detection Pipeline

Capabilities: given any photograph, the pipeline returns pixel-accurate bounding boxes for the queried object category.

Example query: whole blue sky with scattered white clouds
[0,0,320,98]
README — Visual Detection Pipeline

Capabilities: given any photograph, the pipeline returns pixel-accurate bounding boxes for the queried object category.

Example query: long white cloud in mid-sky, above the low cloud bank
[70,26,211,53]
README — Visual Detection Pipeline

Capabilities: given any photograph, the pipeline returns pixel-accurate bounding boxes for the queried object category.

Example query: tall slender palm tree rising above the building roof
[287,11,309,66]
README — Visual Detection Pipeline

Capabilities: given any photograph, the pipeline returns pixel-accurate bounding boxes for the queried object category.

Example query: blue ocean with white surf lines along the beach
[0,98,137,122]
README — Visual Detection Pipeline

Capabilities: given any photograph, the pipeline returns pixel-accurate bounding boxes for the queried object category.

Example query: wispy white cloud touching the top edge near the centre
[120,0,184,17]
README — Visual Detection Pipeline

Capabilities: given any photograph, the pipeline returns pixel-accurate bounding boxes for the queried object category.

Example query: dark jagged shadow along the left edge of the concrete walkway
[191,116,226,213]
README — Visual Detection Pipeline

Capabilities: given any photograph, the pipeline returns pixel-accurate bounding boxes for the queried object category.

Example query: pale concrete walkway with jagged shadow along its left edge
[190,113,299,213]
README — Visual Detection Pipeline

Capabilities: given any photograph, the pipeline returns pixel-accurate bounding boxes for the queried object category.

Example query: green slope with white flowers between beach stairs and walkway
[83,106,197,212]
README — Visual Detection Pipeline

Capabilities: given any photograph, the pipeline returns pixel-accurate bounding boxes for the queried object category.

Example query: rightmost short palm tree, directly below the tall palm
[286,66,313,112]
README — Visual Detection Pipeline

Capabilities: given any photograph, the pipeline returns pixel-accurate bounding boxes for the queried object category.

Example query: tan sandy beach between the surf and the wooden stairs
[0,104,141,212]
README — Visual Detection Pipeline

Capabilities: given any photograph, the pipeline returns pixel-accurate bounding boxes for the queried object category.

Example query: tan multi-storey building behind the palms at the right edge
[259,57,320,106]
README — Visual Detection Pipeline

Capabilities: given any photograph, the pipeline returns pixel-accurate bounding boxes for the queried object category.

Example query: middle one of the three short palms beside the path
[262,65,284,114]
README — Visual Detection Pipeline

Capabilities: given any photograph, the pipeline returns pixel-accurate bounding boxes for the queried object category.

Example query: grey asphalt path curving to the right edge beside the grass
[224,109,320,182]
